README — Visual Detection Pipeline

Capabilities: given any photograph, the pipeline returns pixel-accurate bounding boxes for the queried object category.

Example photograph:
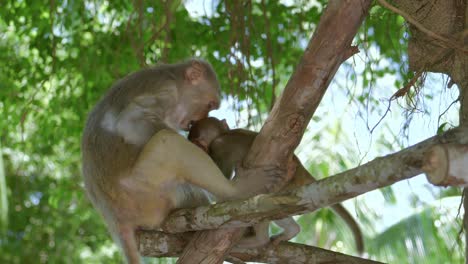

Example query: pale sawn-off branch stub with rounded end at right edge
[422,144,468,187]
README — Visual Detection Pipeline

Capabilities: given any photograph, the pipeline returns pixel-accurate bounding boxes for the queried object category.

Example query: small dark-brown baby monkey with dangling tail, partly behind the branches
[188,117,364,253]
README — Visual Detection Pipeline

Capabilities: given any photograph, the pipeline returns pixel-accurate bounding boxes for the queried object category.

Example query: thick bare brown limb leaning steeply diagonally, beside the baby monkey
[178,0,371,263]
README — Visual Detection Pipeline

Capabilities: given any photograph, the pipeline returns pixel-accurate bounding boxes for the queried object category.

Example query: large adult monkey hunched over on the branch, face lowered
[82,59,283,264]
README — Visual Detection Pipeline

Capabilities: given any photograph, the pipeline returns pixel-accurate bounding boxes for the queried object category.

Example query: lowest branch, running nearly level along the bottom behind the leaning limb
[140,231,380,264]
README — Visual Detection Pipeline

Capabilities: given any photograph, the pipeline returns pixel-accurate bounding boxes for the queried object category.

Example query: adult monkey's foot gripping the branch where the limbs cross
[234,166,288,197]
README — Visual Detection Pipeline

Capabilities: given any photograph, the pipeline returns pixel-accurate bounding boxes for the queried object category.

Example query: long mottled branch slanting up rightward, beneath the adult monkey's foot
[151,127,468,233]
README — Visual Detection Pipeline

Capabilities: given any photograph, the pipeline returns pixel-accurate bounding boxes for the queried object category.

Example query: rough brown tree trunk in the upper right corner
[393,0,467,78]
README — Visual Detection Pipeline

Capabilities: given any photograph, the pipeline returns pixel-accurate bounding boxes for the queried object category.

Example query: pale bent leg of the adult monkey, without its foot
[134,129,241,199]
